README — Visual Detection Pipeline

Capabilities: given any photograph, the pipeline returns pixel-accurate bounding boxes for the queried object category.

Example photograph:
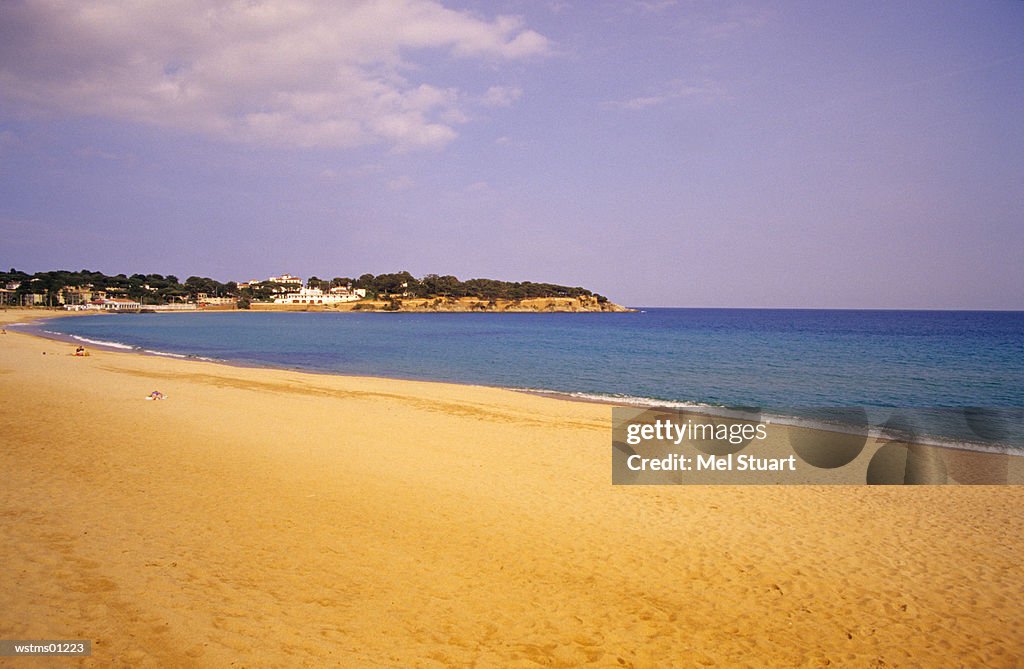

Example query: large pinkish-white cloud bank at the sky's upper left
[0,0,549,151]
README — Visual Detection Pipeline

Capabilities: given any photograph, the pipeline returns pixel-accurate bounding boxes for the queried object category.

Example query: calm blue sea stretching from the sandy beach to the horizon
[24,308,1024,453]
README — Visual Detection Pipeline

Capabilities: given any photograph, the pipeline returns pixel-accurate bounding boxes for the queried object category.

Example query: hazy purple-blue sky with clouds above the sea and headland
[0,0,1024,309]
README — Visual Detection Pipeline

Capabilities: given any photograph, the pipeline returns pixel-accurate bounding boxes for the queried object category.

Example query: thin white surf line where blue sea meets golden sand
[18,310,1024,457]
